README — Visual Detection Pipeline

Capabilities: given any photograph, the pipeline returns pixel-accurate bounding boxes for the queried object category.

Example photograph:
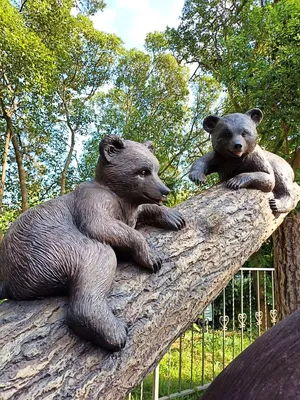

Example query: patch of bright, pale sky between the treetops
[92,0,184,50]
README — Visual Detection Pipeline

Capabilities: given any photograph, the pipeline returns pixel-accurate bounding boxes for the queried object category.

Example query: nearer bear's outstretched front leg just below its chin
[137,204,185,231]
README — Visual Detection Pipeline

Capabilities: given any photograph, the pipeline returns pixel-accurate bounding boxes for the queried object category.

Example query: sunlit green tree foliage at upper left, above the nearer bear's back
[0,0,122,216]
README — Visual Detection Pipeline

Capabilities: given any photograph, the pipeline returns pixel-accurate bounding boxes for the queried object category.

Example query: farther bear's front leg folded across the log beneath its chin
[226,172,275,192]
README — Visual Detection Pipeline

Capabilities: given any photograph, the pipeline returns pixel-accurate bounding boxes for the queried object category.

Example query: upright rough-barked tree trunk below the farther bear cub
[273,212,300,319]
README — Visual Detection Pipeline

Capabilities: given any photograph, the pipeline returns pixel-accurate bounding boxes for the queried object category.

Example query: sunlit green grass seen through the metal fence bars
[131,326,254,400]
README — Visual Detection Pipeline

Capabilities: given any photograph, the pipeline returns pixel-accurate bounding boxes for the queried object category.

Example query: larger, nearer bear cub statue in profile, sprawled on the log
[0,135,185,350]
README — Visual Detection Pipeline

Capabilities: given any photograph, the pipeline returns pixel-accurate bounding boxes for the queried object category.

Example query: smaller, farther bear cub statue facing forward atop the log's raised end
[189,108,295,213]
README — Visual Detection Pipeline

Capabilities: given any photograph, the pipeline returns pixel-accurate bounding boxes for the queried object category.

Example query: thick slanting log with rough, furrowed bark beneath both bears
[0,184,300,400]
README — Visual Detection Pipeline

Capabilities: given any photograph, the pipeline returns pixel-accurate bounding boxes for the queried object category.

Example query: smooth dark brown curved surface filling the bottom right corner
[199,310,300,400]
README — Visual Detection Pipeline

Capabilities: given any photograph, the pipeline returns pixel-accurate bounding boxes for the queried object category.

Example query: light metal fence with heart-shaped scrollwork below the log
[128,268,277,400]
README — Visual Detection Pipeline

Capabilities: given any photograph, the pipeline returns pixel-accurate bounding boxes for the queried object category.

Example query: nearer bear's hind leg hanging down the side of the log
[67,241,127,351]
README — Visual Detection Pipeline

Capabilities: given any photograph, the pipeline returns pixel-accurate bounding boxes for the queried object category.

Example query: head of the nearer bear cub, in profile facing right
[96,135,170,205]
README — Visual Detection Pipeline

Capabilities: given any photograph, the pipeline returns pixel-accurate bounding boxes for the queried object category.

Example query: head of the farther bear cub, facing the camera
[203,108,263,158]
